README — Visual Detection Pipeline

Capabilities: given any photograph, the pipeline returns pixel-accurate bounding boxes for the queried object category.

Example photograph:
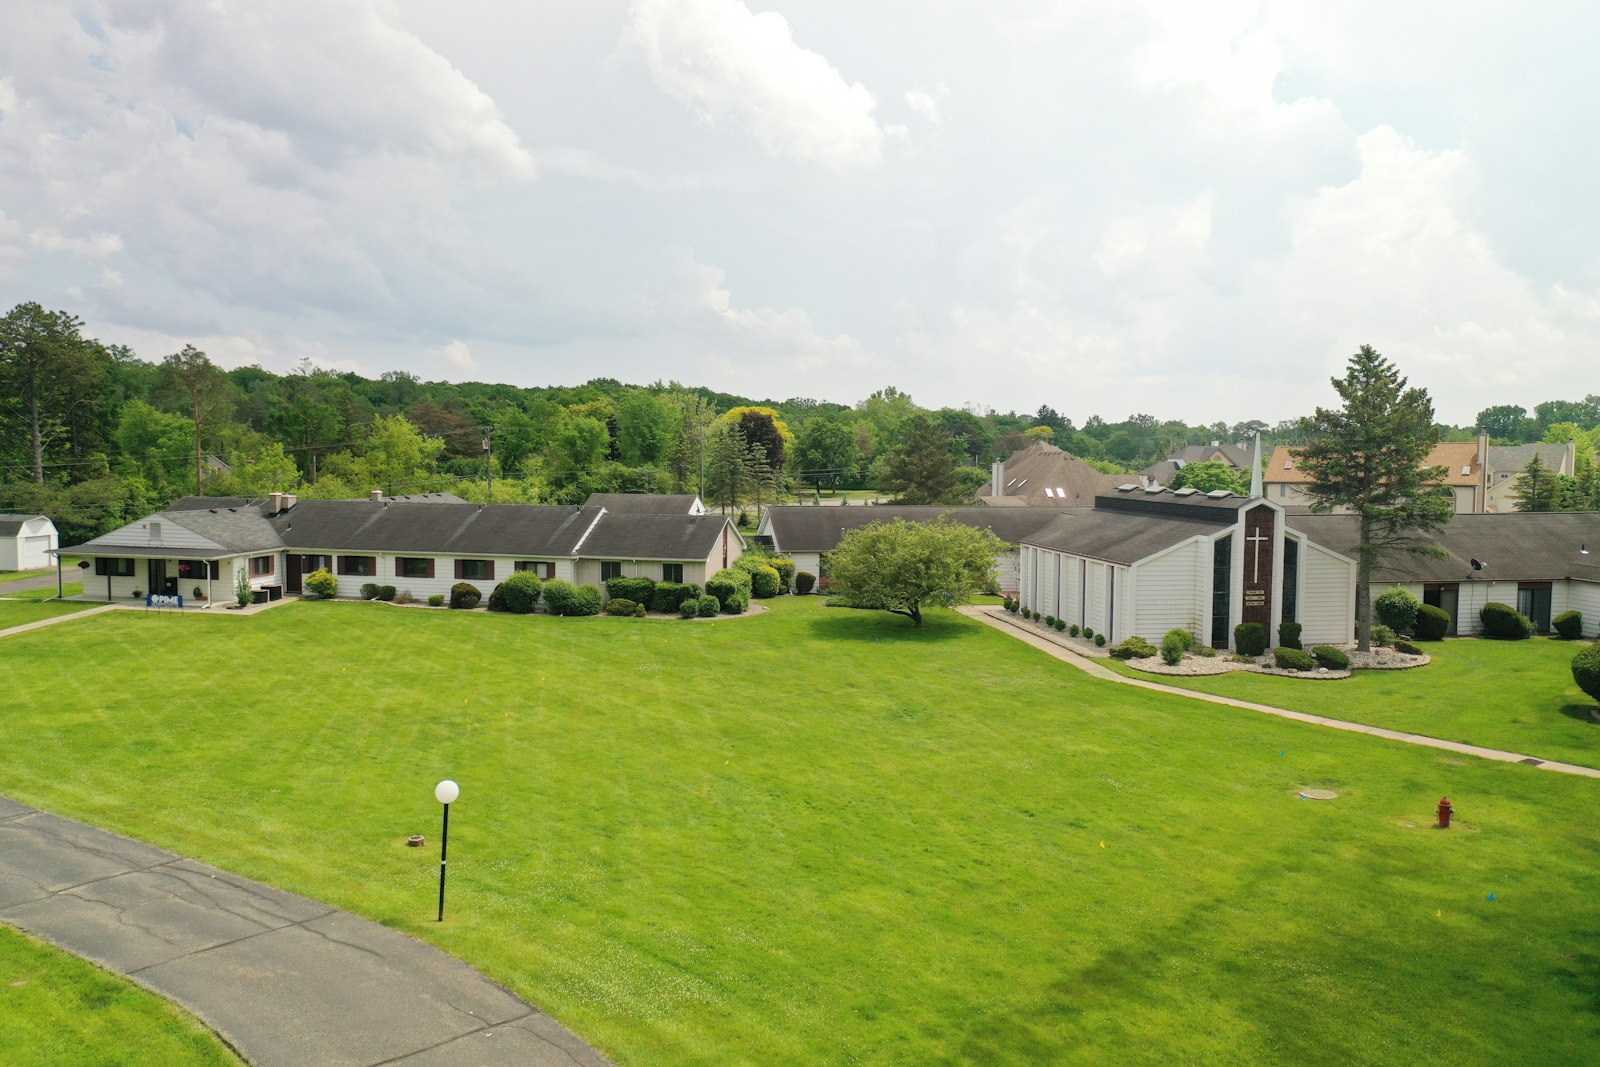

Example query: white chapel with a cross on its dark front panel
[1019,486,1355,648]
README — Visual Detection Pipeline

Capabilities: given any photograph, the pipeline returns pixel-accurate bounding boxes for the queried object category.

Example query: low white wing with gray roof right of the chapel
[1290,512,1600,635]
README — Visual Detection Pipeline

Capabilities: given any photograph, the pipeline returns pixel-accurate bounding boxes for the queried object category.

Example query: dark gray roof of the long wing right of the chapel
[1286,512,1600,582]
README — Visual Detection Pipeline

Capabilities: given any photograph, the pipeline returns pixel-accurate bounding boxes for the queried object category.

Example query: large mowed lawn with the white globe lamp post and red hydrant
[0,598,1600,1065]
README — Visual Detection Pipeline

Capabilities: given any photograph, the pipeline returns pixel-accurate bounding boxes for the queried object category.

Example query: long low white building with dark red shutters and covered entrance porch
[56,493,744,601]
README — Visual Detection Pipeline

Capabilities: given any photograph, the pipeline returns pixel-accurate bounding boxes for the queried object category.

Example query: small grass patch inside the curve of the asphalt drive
[0,921,242,1067]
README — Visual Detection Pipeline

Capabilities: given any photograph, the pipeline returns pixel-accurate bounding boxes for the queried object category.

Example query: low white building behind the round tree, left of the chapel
[757,502,1072,592]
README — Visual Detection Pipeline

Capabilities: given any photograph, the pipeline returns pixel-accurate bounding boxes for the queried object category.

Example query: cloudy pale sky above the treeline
[0,0,1600,424]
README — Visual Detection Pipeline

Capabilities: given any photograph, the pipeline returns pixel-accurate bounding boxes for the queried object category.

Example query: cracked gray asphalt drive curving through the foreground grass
[0,797,610,1067]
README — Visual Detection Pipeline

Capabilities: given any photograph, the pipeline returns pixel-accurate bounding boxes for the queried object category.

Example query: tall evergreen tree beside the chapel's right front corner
[1298,344,1454,651]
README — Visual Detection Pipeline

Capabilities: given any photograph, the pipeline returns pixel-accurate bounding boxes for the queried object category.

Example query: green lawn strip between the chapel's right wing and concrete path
[1102,637,1600,766]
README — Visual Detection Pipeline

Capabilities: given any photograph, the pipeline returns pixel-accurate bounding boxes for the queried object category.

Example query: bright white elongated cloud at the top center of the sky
[632,0,885,170]
